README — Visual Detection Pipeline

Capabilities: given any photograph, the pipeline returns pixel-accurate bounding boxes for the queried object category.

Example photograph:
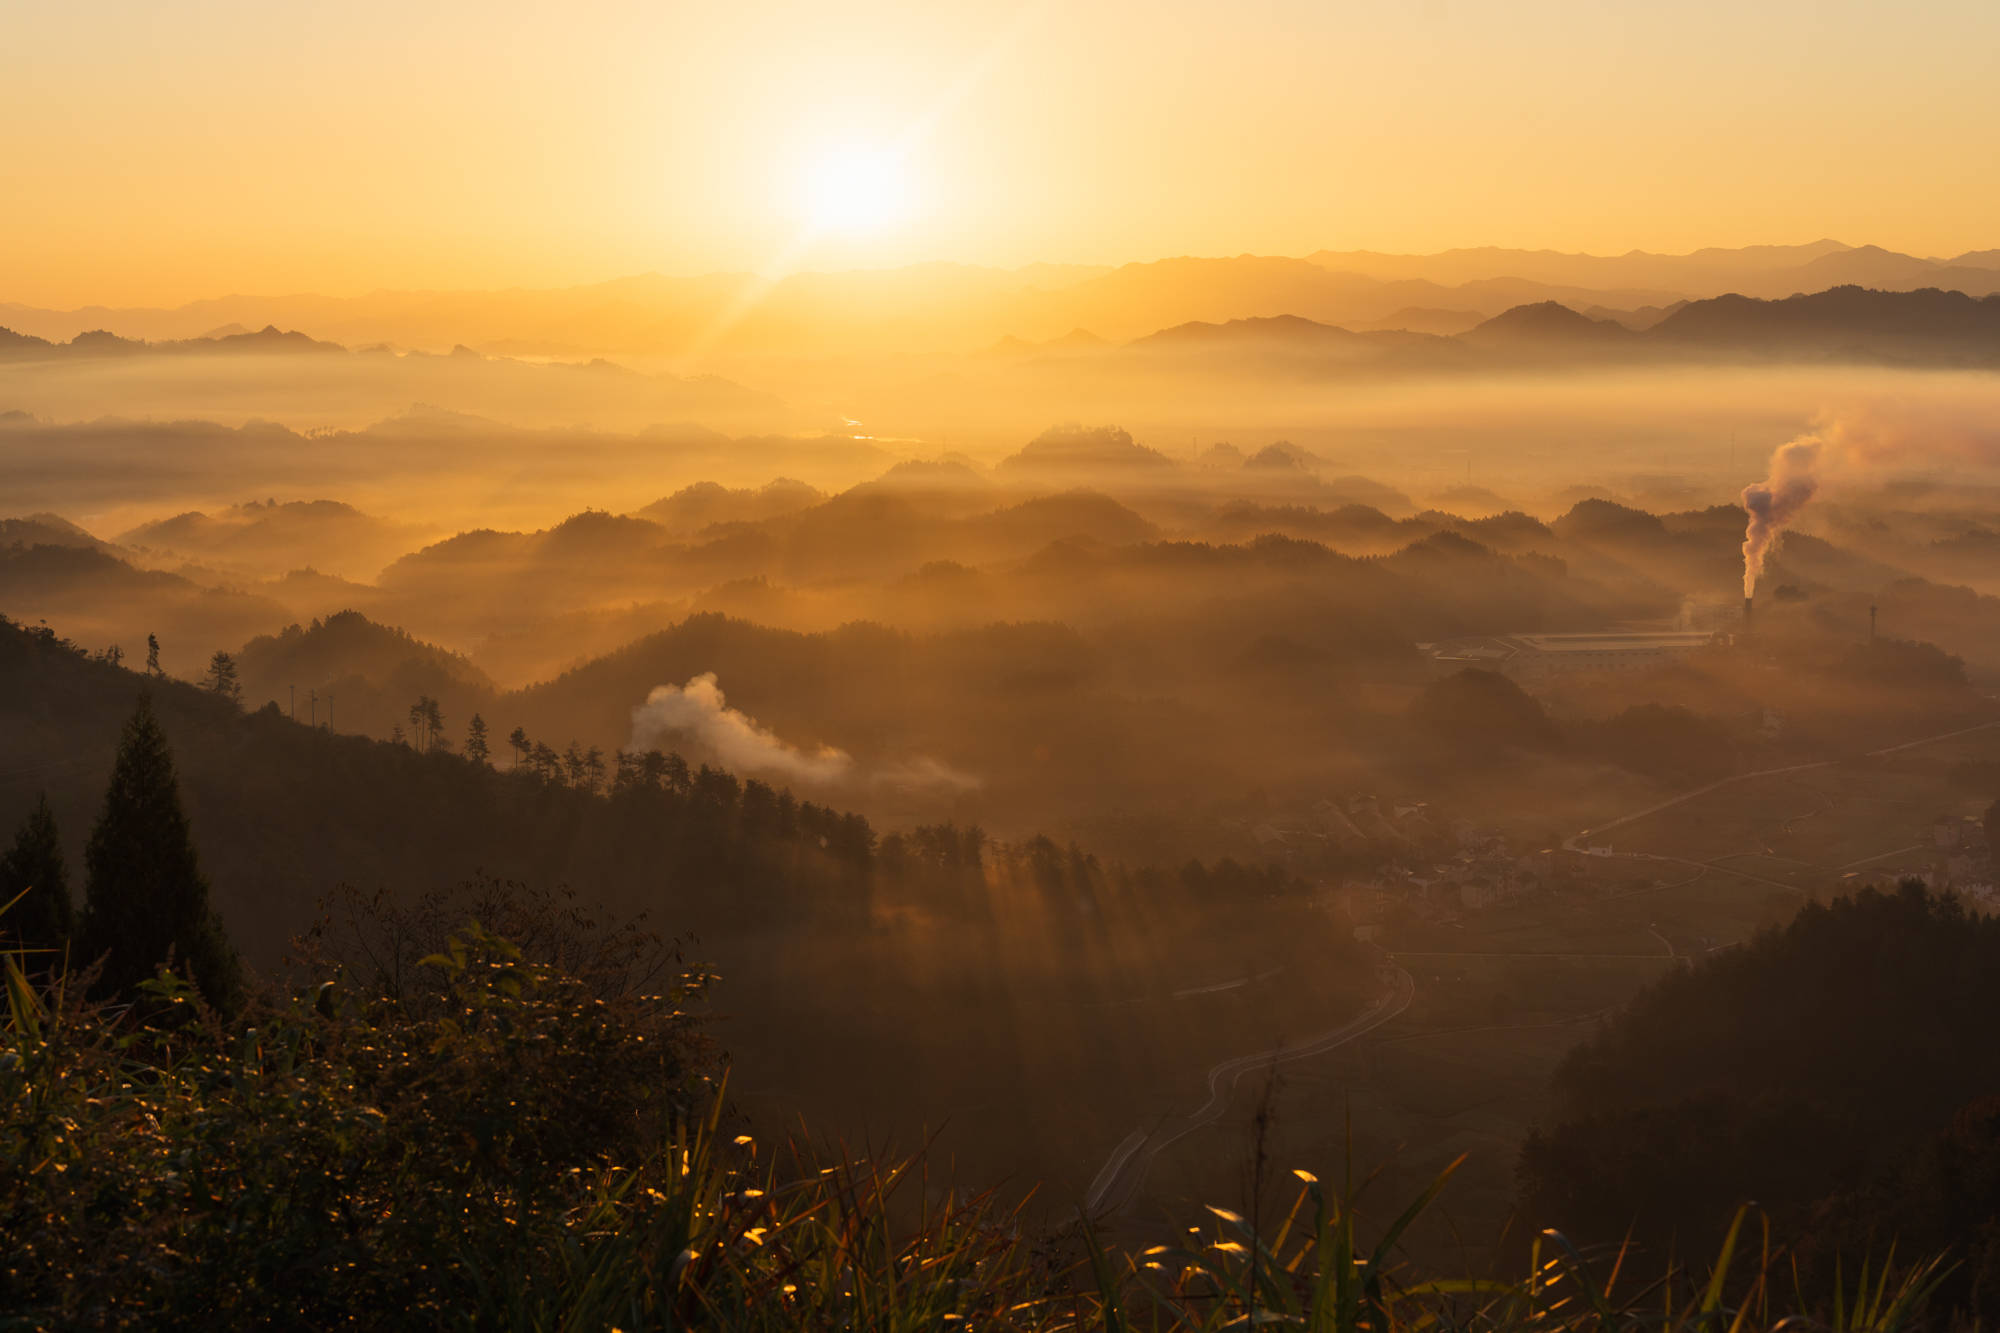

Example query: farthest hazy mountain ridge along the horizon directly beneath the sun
[15,240,2000,360]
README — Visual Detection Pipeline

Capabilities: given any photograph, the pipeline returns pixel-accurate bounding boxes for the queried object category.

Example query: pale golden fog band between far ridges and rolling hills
[0,352,2000,536]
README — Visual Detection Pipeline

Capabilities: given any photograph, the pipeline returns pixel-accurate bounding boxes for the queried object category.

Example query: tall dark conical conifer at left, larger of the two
[76,695,242,1007]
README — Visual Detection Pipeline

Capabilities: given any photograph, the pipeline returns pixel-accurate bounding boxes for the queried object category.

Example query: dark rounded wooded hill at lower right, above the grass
[1522,881,2000,1317]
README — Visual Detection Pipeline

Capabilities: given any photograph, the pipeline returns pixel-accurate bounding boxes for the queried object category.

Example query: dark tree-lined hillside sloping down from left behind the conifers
[0,622,1376,1199]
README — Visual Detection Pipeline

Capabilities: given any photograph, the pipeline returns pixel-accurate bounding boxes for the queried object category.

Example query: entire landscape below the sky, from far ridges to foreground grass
[11,242,2000,1331]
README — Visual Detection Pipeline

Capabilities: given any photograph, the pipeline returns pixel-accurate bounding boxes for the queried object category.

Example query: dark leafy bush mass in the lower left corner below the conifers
[0,929,714,1327]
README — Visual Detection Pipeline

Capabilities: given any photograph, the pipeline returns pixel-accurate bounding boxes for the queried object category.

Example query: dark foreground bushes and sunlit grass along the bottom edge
[0,931,1944,1333]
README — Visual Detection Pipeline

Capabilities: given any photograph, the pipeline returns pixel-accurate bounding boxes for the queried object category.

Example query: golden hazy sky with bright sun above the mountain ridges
[0,0,2000,304]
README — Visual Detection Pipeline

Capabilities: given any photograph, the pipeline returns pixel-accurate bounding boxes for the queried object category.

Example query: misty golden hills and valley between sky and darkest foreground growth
[11,242,2000,1264]
